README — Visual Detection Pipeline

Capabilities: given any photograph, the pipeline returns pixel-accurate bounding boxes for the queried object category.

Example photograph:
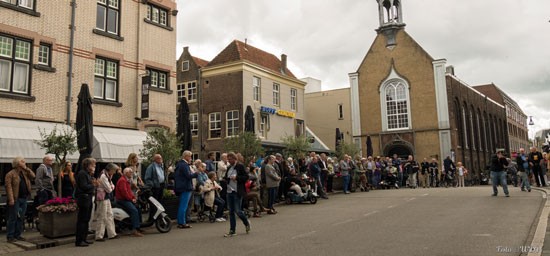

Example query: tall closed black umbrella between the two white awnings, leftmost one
[76,84,94,170]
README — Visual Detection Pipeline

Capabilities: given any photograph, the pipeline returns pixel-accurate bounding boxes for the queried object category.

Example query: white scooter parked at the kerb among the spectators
[113,187,172,233]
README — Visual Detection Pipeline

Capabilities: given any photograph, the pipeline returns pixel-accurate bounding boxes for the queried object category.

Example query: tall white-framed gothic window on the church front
[382,79,410,130]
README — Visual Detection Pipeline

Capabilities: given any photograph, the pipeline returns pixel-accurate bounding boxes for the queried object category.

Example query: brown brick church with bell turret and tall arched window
[349,0,509,173]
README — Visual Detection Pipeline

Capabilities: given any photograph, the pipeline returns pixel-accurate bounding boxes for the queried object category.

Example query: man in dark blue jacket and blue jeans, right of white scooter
[174,150,198,228]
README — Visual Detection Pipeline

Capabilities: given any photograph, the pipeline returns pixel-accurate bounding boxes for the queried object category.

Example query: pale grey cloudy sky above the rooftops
[177,0,550,137]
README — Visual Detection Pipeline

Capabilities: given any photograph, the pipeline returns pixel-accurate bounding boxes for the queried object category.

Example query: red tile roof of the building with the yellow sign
[207,40,296,79]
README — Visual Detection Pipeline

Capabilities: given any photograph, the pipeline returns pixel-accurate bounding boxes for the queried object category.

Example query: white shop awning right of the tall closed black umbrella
[92,126,147,163]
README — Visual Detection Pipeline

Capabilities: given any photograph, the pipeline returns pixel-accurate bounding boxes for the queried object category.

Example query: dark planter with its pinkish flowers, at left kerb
[36,197,78,238]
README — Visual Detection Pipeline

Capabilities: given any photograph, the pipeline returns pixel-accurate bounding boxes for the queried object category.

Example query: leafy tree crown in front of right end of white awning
[139,128,181,168]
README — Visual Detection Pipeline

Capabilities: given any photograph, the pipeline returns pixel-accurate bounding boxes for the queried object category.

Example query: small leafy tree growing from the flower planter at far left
[34,125,78,196]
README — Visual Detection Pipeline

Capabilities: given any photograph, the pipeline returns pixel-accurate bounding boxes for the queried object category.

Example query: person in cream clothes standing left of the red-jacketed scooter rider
[94,163,120,242]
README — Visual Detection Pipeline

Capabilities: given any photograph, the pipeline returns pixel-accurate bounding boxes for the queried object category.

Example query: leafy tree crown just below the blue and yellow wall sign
[223,132,264,164]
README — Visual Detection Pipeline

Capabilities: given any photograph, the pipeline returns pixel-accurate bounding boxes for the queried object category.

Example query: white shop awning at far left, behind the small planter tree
[0,118,78,163]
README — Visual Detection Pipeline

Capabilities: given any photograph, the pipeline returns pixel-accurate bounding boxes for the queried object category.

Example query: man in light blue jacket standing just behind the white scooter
[145,154,166,221]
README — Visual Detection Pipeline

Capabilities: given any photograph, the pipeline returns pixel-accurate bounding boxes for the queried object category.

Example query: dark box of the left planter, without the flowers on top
[38,211,78,238]
